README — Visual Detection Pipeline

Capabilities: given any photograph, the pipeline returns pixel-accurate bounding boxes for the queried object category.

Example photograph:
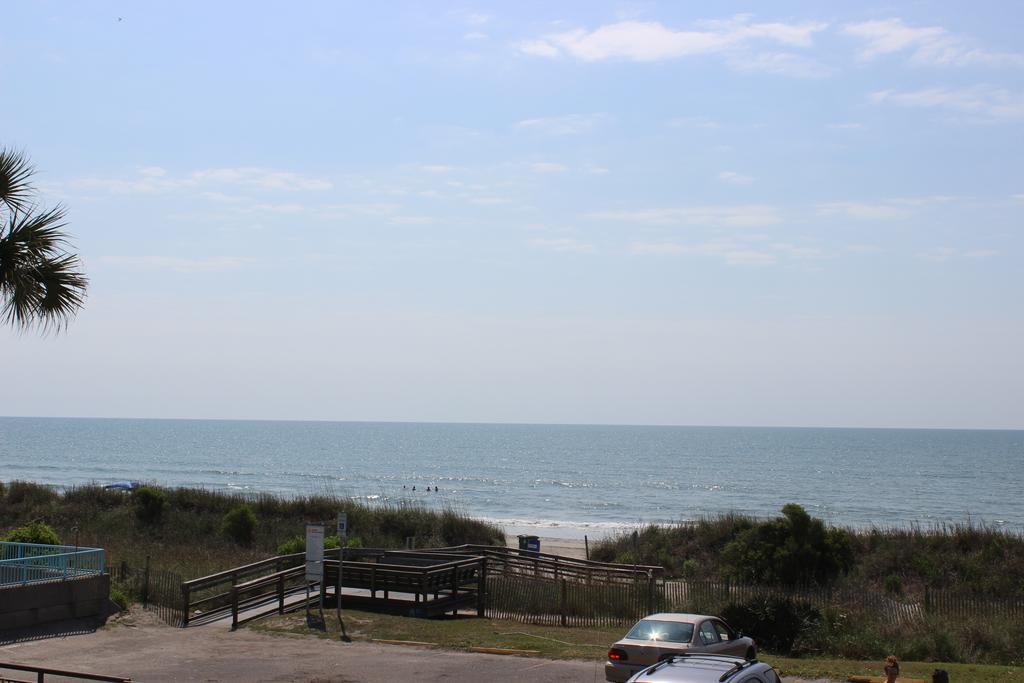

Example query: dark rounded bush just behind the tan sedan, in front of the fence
[722,597,821,654]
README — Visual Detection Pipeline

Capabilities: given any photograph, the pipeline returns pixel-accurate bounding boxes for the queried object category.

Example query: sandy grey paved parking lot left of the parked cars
[0,609,831,683]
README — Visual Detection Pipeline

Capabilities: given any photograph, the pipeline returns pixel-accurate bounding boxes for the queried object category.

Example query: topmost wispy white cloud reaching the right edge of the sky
[843,18,1024,67]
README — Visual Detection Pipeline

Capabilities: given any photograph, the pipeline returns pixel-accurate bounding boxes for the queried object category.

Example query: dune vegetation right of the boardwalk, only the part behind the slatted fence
[591,504,1024,598]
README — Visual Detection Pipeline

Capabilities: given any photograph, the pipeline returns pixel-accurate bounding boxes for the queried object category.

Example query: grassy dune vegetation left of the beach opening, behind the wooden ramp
[0,481,504,578]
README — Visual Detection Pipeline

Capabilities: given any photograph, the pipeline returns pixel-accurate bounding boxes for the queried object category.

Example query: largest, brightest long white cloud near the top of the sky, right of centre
[518,15,827,75]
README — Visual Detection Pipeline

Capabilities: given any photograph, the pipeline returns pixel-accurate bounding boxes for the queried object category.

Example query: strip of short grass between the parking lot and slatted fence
[248,610,1024,683]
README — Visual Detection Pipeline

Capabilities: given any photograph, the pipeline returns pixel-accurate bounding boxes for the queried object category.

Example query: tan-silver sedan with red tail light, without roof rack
[604,612,758,683]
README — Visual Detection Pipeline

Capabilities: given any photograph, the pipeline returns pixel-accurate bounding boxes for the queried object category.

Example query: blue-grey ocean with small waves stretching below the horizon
[0,418,1024,538]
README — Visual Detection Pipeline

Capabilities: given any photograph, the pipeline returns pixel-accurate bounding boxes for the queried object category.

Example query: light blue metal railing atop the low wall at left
[0,541,104,586]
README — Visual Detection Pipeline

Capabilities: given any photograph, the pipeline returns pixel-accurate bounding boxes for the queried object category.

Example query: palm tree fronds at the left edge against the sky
[0,147,89,332]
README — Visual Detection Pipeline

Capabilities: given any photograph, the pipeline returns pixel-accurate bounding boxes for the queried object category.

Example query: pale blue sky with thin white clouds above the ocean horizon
[0,1,1024,428]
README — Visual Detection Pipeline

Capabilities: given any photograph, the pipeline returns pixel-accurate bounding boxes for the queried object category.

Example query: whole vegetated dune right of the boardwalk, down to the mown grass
[591,504,1024,663]
